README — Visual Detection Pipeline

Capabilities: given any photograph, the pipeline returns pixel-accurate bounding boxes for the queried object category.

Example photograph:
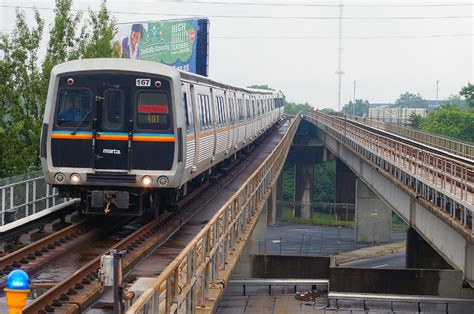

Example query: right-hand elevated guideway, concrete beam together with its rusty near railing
[305,111,474,281]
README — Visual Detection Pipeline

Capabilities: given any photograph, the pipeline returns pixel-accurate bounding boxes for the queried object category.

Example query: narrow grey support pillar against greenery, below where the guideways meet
[295,163,314,219]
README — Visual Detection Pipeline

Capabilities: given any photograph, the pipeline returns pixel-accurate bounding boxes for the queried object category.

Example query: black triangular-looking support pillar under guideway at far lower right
[406,227,451,269]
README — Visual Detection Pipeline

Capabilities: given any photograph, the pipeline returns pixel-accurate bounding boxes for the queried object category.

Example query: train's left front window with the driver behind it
[57,89,91,127]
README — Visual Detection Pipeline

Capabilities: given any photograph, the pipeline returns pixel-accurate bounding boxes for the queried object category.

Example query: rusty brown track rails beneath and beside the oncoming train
[0,117,294,313]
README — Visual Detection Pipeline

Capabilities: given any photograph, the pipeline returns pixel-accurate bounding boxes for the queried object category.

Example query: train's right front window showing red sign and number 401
[137,91,171,130]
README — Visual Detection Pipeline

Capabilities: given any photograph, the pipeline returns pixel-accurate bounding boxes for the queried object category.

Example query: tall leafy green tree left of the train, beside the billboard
[0,0,114,177]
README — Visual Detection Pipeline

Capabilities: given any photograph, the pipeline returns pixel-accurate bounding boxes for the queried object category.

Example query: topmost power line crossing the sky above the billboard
[0,4,474,20]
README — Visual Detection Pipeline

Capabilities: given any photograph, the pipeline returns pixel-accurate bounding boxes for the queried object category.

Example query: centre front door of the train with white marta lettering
[93,86,133,171]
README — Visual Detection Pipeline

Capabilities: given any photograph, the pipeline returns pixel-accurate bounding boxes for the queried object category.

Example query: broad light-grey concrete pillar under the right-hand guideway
[355,179,392,243]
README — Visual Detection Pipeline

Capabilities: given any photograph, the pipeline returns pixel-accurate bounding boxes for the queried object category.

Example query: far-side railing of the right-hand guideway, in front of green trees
[328,114,474,159]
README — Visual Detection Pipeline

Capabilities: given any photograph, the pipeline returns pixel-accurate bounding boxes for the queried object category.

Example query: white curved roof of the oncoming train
[51,58,277,95]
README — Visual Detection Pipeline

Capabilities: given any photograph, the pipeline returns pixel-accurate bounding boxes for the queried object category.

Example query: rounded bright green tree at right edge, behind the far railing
[420,105,474,142]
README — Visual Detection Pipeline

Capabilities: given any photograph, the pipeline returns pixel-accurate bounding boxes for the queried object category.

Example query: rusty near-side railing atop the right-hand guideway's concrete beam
[306,111,474,233]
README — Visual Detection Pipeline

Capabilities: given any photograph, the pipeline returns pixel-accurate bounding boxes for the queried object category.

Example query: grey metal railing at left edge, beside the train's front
[0,171,72,226]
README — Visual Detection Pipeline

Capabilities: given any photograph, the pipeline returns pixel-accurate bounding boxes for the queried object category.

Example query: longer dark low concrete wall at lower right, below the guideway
[329,267,463,297]
